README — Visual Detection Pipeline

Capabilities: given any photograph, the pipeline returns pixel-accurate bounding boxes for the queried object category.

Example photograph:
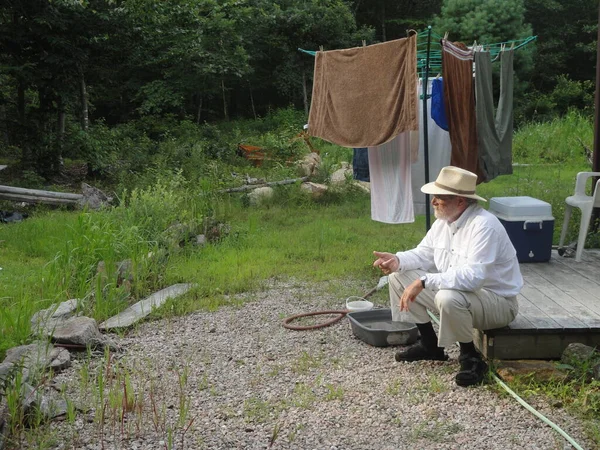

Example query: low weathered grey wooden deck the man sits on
[475,249,600,359]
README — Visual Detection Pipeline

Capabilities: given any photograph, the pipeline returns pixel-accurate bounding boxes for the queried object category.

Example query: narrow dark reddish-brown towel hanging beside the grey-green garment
[442,39,484,183]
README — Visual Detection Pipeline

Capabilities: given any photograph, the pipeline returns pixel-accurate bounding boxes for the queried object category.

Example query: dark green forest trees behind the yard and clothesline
[0,0,598,181]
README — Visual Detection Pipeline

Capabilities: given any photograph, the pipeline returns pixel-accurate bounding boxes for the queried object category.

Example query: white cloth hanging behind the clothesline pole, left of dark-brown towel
[411,79,452,215]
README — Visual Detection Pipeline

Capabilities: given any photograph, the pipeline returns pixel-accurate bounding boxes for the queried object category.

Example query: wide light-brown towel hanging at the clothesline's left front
[308,35,419,147]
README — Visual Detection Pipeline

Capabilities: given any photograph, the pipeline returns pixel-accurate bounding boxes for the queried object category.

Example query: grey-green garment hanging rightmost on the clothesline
[475,50,514,181]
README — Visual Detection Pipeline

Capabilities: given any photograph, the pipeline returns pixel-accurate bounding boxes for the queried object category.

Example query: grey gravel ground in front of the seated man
[47,282,591,450]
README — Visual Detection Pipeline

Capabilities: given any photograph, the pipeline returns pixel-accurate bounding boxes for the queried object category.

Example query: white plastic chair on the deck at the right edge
[558,172,600,262]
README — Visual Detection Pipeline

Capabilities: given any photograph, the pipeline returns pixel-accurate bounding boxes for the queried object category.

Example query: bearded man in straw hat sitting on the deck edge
[373,166,523,386]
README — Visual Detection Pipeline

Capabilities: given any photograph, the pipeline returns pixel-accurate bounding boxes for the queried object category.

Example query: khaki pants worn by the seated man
[389,270,519,347]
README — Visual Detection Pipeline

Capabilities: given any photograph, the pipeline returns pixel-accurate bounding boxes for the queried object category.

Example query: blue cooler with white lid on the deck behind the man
[489,197,554,262]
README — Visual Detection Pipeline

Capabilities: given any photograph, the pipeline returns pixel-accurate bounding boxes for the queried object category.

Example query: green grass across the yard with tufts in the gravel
[0,108,600,446]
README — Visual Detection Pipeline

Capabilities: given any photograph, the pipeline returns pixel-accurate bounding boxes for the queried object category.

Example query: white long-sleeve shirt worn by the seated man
[396,204,523,297]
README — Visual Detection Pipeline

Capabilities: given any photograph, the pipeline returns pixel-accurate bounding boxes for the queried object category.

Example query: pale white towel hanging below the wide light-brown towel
[369,132,415,223]
